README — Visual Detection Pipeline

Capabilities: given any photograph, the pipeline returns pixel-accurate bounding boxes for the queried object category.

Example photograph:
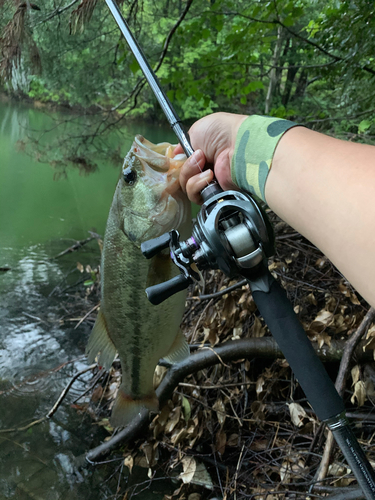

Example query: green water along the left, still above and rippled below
[0,102,178,500]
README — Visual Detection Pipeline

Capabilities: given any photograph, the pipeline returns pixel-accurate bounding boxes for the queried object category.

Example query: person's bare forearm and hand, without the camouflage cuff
[181,113,375,306]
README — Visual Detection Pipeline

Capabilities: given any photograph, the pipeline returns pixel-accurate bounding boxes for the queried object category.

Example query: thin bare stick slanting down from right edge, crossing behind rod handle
[314,307,375,486]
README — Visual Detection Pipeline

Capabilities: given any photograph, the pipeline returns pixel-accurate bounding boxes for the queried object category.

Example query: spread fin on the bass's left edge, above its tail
[86,310,117,370]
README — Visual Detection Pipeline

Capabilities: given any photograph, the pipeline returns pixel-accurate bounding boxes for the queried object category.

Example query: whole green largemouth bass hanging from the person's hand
[86,135,191,427]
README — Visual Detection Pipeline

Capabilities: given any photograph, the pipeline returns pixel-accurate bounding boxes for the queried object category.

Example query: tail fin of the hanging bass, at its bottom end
[110,384,159,427]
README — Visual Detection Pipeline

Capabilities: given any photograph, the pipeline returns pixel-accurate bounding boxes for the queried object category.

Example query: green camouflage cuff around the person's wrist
[231,115,298,201]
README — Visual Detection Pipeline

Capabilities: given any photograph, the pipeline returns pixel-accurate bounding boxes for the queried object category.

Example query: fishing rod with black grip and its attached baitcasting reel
[106,0,375,500]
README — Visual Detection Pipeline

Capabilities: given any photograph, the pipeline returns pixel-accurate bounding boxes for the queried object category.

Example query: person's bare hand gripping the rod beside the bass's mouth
[174,113,247,205]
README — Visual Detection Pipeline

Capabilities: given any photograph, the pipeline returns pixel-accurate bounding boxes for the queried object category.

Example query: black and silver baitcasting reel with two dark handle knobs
[141,183,274,305]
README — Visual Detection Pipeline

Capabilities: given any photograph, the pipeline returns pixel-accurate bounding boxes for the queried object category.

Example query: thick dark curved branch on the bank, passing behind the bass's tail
[86,337,372,464]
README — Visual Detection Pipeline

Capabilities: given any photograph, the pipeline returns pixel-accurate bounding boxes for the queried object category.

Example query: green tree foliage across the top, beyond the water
[0,0,375,150]
